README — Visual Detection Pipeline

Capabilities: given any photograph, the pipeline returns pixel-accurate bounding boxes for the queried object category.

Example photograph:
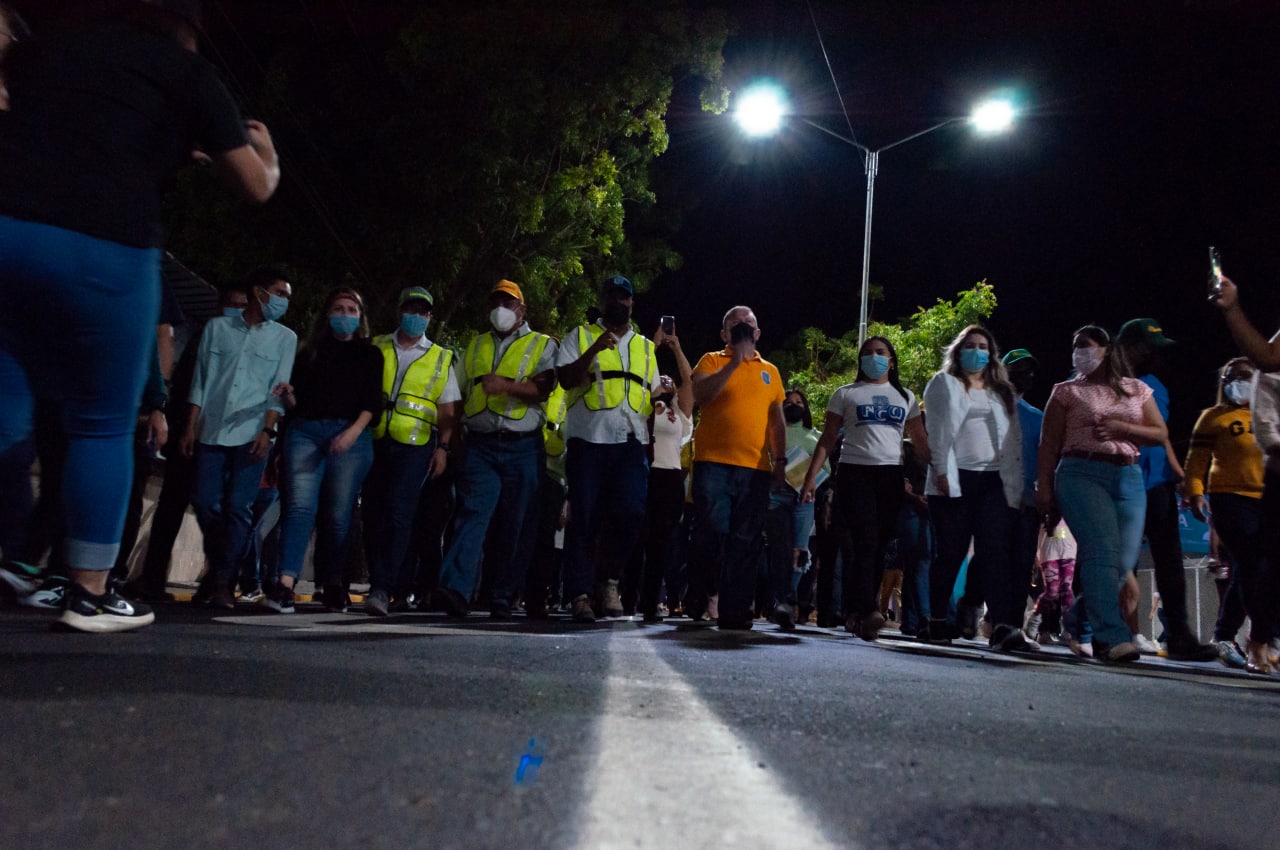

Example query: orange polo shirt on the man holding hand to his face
[694,348,786,471]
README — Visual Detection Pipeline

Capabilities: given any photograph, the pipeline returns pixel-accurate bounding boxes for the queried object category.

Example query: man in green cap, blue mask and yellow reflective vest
[361,287,462,617]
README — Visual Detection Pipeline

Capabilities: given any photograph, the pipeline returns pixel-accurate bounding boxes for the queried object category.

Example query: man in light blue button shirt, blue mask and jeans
[182,268,298,608]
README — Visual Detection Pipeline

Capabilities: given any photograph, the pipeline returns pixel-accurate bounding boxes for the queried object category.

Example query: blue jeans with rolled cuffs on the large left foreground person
[0,216,160,570]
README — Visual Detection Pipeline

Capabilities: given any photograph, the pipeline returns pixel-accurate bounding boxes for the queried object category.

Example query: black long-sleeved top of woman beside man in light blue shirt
[289,334,383,420]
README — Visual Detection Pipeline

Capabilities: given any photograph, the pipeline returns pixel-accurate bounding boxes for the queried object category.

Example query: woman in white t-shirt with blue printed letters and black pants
[800,337,927,640]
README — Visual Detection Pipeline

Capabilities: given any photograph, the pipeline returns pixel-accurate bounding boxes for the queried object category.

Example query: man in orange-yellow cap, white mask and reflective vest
[436,280,558,620]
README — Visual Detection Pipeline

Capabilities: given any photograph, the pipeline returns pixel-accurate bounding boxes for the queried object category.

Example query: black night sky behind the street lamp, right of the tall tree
[639,0,1280,443]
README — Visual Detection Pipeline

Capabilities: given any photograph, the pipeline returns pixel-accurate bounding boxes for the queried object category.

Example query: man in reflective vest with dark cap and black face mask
[556,275,658,622]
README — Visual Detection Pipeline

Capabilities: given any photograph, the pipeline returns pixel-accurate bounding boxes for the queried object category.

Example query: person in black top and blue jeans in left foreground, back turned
[0,1,280,632]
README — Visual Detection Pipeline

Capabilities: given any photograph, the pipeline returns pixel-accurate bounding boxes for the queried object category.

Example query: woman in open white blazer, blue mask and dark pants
[924,325,1029,650]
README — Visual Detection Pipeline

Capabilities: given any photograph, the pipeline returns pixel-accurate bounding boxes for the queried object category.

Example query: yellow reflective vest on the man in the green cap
[374,333,453,445]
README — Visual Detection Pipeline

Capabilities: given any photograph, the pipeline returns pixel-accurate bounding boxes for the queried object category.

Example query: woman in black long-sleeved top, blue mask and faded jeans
[262,288,383,613]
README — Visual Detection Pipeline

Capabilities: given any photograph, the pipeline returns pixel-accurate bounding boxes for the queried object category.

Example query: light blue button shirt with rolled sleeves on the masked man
[187,316,298,445]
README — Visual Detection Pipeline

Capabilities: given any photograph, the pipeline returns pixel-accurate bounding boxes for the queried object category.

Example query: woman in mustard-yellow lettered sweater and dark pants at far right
[1185,357,1271,673]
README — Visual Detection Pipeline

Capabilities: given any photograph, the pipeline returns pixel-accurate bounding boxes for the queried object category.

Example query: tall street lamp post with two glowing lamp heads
[735,86,1014,351]
